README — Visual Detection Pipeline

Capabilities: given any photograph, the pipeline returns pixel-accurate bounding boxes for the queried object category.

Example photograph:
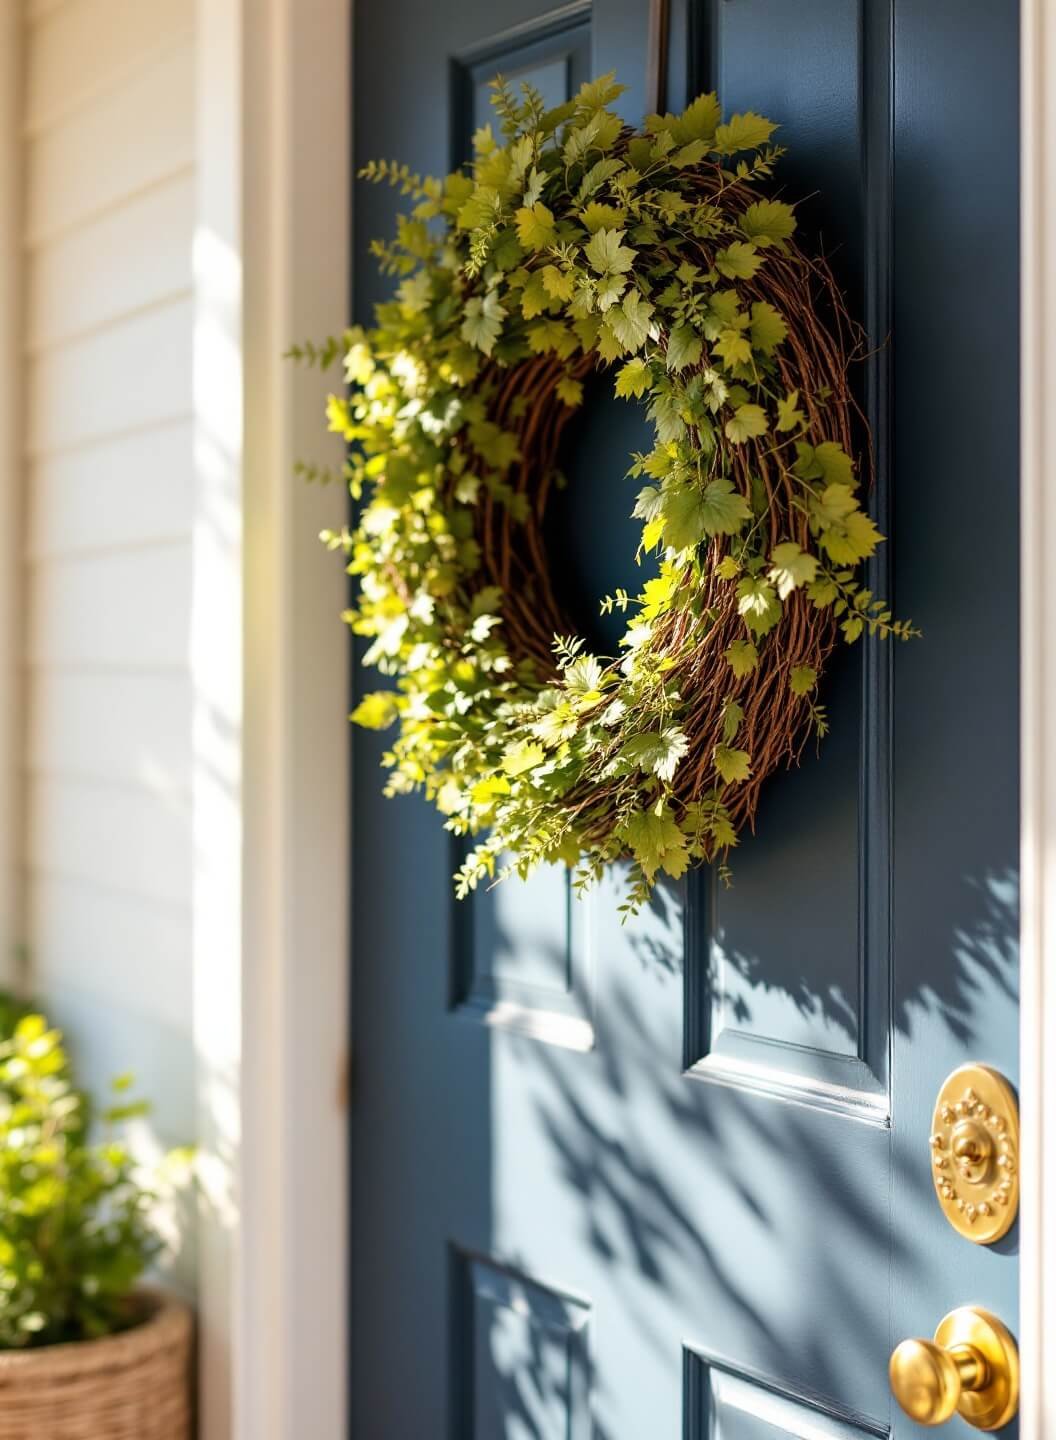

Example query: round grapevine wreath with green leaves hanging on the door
[292,75,913,912]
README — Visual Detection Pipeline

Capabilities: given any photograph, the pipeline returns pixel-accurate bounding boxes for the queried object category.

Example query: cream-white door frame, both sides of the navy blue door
[191,0,1056,1440]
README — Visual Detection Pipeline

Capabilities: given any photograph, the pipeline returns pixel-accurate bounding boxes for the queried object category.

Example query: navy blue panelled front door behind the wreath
[350,0,1019,1440]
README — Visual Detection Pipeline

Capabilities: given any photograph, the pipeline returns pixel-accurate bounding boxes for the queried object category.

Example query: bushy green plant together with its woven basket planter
[0,1012,192,1440]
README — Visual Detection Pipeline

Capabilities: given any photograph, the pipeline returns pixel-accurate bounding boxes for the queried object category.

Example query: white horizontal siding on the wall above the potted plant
[23,0,194,1283]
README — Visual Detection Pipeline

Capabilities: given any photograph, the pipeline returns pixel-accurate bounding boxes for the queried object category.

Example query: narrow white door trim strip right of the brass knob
[1020,0,1056,1440]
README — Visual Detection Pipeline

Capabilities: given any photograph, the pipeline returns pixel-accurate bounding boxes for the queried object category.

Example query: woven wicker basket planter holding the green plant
[0,1295,192,1440]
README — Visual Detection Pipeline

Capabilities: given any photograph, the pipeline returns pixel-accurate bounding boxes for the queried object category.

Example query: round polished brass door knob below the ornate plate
[889,1306,1020,1430]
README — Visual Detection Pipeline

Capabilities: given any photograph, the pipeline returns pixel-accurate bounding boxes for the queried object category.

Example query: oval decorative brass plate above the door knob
[931,1066,1020,1246]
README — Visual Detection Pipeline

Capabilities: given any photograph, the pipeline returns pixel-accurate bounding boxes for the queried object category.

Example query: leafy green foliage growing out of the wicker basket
[0,1014,190,1349]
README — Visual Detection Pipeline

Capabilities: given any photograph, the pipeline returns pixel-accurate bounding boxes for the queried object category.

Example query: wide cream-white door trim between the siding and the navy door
[192,0,350,1440]
